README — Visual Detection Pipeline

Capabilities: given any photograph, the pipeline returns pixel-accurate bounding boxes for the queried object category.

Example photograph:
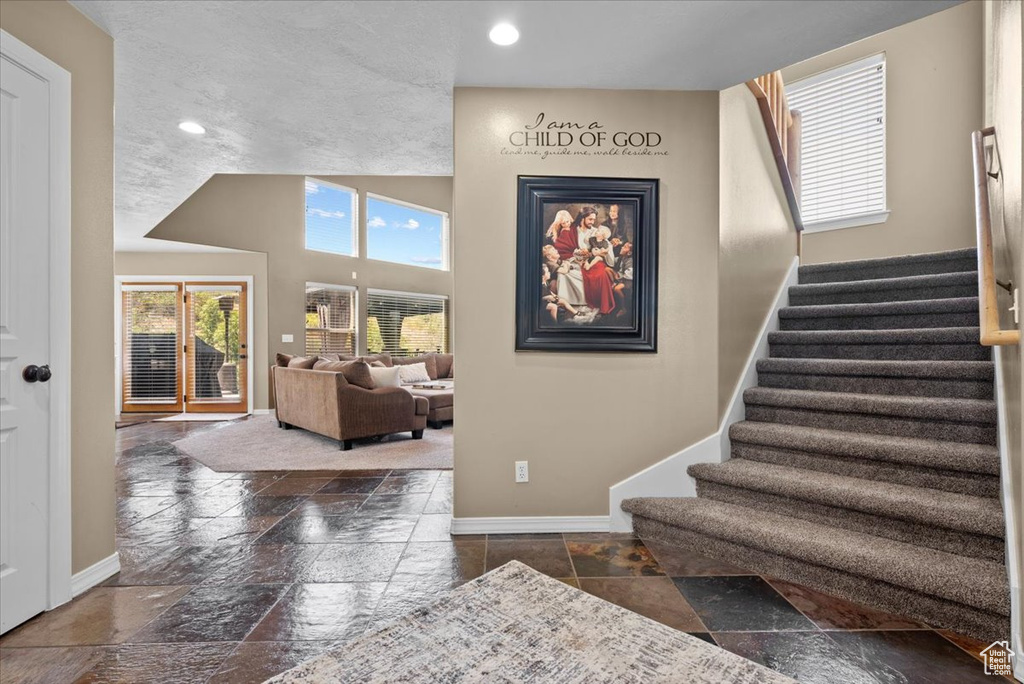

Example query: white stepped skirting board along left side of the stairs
[608,257,800,532]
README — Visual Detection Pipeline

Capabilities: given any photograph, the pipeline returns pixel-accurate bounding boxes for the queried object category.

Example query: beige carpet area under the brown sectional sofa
[174,416,453,472]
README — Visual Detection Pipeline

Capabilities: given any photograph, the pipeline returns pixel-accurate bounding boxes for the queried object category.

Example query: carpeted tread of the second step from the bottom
[687,459,1004,538]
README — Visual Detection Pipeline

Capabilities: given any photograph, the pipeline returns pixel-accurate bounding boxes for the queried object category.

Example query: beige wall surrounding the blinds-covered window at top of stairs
[782,2,984,263]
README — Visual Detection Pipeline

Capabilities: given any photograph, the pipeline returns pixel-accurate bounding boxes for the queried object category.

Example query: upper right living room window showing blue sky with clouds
[367,193,449,270]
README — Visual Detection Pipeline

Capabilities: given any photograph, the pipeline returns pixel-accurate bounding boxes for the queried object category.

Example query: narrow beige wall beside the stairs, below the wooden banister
[718,84,797,419]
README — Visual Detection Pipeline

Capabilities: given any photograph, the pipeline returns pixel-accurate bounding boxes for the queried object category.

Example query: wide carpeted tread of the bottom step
[622,498,1010,615]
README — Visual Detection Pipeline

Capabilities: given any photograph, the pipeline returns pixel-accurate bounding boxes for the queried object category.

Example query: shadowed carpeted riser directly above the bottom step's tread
[696,479,1005,562]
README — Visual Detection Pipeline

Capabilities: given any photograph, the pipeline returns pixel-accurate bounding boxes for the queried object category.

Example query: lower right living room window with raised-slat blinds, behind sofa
[367,290,449,356]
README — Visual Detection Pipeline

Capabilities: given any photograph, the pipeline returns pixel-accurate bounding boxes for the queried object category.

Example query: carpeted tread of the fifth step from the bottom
[757,358,995,382]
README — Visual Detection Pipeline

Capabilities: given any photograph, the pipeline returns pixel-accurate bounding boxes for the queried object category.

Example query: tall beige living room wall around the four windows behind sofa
[148,174,455,405]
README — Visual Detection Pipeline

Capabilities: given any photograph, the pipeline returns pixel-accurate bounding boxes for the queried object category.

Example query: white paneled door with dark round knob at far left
[0,44,58,633]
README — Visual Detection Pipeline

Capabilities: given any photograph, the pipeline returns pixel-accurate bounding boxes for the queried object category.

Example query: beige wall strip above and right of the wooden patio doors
[114,252,272,410]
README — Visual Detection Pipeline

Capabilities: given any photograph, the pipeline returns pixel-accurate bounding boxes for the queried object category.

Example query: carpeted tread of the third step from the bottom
[729,421,999,475]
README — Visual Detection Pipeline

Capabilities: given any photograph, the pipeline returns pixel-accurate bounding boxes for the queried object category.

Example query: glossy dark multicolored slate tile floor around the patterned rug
[0,423,1007,684]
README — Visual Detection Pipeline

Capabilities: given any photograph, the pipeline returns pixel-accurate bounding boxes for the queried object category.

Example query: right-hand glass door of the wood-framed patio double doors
[184,283,249,413]
